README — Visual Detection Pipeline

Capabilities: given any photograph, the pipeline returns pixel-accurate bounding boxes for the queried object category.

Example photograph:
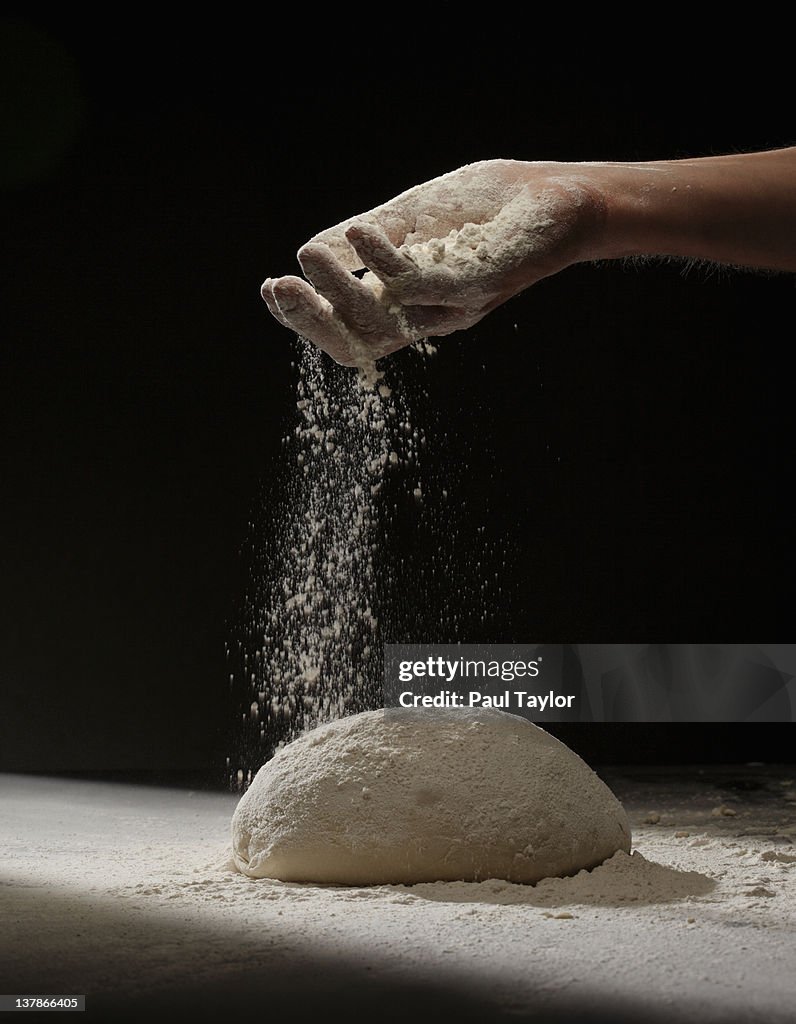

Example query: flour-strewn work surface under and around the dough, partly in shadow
[0,766,796,1024]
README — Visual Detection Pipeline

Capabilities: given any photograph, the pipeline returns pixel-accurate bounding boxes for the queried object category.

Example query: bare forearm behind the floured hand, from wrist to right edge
[557,147,796,271]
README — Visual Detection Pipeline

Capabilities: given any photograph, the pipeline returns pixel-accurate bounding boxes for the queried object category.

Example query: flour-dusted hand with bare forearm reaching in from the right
[262,147,796,366]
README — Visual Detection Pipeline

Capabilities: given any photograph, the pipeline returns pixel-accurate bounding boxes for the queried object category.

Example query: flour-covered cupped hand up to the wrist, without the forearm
[262,160,601,367]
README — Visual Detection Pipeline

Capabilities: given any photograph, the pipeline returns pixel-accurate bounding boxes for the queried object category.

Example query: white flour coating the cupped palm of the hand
[312,162,561,386]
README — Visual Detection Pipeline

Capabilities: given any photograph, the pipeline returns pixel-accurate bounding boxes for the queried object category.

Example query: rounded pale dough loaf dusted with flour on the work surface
[233,709,630,885]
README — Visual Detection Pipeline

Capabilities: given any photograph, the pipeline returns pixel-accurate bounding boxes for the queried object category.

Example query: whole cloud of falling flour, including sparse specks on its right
[227,343,506,790]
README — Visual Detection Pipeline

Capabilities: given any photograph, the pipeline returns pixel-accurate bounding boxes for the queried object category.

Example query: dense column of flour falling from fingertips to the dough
[231,345,401,776]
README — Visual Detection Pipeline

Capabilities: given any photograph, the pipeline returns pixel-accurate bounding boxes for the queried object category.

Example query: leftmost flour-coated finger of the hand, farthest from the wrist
[261,278,355,366]
